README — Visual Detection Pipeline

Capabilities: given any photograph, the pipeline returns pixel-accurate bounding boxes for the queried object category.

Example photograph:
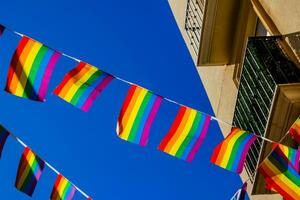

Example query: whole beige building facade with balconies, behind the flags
[169,0,300,200]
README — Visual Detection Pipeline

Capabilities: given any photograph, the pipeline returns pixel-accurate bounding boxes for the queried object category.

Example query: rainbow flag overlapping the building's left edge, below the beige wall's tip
[210,128,257,173]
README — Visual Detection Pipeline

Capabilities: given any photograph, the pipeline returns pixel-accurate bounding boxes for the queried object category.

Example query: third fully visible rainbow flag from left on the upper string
[117,85,162,146]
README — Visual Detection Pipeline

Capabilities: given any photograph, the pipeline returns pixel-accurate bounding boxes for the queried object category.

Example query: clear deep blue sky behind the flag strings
[0,0,242,200]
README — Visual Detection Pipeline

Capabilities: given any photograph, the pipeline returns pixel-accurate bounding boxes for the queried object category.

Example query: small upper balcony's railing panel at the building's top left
[185,0,206,55]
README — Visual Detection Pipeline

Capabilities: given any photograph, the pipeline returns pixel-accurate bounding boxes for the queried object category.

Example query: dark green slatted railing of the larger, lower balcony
[233,37,300,182]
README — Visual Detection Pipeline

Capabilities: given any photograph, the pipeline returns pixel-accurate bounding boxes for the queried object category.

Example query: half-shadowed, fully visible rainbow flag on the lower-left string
[15,147,45,196]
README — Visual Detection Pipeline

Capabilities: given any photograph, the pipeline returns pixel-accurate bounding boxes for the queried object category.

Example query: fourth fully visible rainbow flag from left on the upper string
[158,106,211,162]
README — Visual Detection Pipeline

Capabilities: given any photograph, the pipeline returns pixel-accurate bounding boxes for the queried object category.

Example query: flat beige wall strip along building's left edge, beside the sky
[169,0,237,136]
